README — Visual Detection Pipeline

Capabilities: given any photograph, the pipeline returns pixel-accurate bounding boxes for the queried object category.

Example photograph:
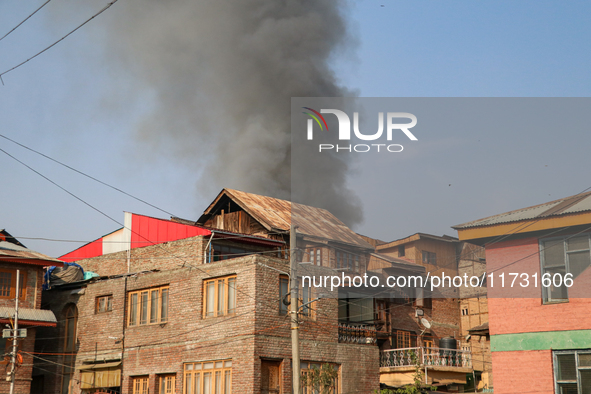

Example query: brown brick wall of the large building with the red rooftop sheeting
[39,254,379,394]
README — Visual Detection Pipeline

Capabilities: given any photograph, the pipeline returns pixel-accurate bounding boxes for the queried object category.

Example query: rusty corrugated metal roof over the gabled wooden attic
[200,189,373,250]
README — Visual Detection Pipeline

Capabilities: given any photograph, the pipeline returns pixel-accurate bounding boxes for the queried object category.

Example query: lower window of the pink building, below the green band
[553,349,591,394]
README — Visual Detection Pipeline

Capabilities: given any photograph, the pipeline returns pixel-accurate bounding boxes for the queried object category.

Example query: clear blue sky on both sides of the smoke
[0,0,591,256]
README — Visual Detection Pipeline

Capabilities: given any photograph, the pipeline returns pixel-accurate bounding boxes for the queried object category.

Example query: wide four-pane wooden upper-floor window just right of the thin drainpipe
[127,285,170,327]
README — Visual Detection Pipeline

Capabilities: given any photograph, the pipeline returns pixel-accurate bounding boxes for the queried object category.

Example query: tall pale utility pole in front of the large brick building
[289,224,300,394]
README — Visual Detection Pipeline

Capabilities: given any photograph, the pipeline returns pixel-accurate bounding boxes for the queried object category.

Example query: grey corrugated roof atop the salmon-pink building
[452,192,591,230]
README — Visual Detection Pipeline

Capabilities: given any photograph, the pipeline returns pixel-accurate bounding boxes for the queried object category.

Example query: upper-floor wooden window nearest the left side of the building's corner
[203,275,236,317]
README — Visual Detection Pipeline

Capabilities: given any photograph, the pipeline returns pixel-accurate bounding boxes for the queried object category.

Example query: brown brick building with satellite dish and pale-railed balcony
[370,233,480,391]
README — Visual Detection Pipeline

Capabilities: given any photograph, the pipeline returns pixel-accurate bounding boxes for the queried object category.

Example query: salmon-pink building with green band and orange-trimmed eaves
[454,193,591,394]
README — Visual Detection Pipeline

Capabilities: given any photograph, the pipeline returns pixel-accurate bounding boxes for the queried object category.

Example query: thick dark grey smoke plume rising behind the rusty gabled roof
[99,0,362,225]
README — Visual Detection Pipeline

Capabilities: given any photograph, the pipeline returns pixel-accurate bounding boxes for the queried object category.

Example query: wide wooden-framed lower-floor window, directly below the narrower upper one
[183,360,232,394]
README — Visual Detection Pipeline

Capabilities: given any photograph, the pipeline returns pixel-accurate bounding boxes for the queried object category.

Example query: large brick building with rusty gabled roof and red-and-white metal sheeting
[36,189,379,394]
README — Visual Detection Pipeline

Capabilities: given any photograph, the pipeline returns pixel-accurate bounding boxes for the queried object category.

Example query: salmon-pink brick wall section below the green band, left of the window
[492,350,554,394]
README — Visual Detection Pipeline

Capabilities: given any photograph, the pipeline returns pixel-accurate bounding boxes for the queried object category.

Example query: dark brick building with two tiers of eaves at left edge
[0,230,63,394]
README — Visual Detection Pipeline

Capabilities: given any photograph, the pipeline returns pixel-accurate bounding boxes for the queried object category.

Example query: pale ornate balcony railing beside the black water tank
[380,347,472,368]
